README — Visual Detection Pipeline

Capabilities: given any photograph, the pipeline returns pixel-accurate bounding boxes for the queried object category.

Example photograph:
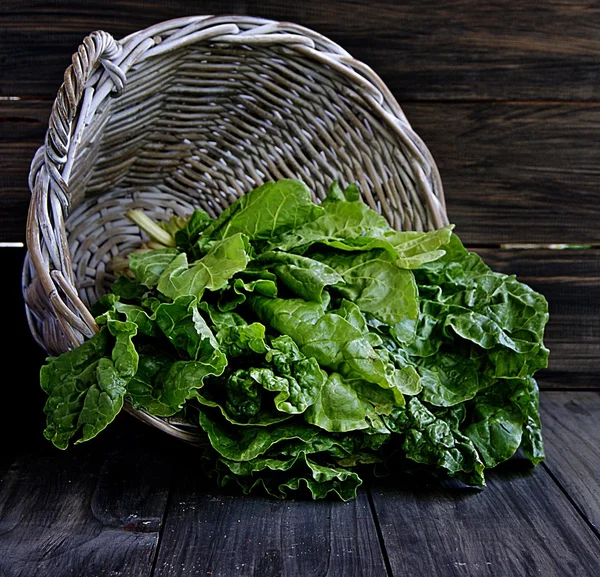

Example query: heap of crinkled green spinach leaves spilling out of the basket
[41,180,548,500]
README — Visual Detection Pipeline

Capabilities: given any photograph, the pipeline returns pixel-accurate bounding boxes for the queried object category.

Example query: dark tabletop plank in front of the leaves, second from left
[153,453,386,577]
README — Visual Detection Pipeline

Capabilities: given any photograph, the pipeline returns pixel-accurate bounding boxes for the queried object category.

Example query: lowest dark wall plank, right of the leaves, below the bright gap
[475,248,600,388]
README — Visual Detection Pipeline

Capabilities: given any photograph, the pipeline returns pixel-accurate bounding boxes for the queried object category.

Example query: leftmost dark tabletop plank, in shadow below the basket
[0,415,173,577]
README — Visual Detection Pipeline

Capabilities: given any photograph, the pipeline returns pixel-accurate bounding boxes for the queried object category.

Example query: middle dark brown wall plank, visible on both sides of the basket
[0,100,600,246]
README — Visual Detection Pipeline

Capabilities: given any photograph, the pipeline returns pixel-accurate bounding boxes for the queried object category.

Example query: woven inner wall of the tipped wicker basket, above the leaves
[66,44,432,303]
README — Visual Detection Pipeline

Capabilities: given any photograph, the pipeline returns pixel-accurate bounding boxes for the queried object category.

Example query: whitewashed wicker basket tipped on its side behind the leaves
[23,16,447,444]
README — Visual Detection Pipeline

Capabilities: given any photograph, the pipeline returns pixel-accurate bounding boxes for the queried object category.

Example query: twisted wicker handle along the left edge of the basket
[26,30,125,352]
